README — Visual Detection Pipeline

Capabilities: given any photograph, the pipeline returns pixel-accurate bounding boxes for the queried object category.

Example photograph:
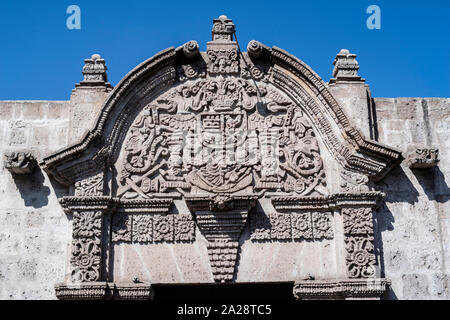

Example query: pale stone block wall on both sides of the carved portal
[0,97,450,299]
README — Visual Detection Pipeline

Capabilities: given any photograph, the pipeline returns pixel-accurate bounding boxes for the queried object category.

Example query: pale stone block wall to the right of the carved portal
[375,98,450,299]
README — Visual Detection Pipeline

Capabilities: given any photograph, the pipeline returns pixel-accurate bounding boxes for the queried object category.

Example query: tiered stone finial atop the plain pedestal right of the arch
[330,49,364,83]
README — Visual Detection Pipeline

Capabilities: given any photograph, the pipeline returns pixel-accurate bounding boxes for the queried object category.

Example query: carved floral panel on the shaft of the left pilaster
[70,211,103,282]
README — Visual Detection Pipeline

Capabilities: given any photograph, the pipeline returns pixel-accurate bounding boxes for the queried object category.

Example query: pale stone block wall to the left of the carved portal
[0,101,71,299]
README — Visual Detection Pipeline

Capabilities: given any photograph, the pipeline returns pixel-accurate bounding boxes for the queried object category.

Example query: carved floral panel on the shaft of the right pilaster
[342,208,377,278]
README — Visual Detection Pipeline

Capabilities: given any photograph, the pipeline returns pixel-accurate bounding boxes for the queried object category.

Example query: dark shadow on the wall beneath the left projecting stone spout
[13,166,68,209]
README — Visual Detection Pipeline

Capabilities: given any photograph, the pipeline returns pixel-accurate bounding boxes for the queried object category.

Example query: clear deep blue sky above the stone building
[0,0,450,100]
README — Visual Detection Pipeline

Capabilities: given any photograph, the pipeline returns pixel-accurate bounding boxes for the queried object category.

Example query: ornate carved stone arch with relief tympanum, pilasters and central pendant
[41,16,402,298]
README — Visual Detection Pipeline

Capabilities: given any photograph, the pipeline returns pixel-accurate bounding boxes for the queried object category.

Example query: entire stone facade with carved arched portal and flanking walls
[0,16,450,299]
